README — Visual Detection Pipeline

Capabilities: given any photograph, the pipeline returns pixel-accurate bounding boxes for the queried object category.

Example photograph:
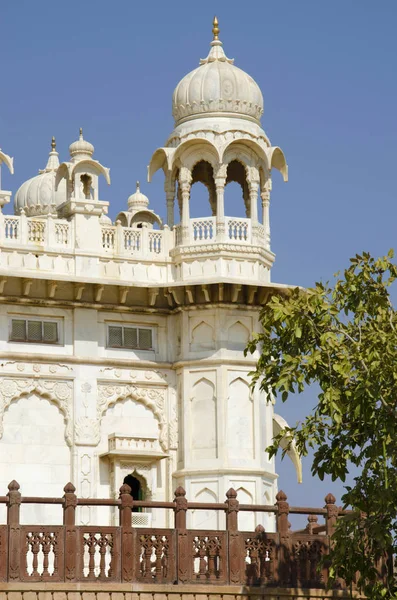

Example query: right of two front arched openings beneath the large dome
[225,160,251,218]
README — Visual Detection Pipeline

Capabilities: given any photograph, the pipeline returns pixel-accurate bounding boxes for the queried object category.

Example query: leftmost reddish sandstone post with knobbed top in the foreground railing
[7,480,21,581]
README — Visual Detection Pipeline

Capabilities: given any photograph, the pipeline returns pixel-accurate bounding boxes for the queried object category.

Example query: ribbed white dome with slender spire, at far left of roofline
[14,138,66,216]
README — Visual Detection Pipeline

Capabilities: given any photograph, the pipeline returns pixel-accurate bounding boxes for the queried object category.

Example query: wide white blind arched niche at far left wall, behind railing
[0,392,71,525]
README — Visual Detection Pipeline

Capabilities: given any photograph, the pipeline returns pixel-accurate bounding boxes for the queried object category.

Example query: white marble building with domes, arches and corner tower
[0,22,299,528]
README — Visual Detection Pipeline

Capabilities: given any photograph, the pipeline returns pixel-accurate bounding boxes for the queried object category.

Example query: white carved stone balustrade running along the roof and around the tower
[0,212,274,285]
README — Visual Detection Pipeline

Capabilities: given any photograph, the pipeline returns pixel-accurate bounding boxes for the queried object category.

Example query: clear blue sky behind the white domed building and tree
[0,0,397,516]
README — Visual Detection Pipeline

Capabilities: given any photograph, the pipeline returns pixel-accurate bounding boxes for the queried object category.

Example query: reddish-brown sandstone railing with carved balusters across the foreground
[0,481,352,588]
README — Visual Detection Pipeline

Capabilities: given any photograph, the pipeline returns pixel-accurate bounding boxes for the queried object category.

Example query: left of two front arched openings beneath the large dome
[190,160,216,219]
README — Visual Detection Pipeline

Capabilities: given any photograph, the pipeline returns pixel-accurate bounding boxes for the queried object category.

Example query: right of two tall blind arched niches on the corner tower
[227,377,254,460]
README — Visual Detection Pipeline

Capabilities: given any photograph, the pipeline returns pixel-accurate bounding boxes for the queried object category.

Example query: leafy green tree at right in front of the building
[246,251,397,599]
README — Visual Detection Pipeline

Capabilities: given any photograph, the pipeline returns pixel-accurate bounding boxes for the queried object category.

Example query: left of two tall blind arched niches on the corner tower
[191,377,218,460]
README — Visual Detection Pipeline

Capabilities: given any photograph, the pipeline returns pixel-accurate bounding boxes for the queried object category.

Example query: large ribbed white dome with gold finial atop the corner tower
[172,24,263,125]
